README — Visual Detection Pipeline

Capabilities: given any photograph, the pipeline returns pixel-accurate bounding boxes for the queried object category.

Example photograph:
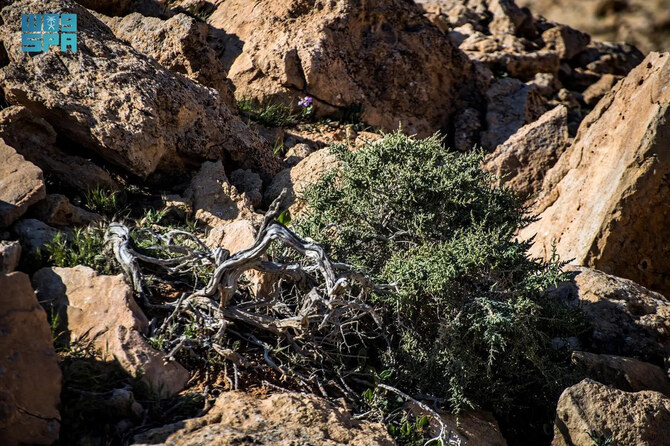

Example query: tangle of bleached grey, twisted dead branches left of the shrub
[105,192,384,399]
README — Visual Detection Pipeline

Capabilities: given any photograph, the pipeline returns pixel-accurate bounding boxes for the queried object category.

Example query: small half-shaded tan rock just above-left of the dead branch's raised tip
[184,161,253,227]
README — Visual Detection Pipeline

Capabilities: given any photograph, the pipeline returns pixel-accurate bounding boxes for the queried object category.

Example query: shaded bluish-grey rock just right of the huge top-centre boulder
[482,78,546,150]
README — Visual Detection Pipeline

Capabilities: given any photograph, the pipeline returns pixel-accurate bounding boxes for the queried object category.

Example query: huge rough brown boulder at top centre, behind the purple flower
[208,0,473,135]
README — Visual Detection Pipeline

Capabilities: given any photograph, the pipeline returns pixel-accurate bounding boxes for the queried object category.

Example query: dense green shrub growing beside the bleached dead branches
[294,132,580,432]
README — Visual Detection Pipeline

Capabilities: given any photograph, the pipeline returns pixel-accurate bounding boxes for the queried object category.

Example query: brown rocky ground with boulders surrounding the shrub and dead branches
[0,0,670,446]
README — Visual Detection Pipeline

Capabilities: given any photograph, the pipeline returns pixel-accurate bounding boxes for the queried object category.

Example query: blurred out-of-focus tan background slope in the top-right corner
[517,0,670,52]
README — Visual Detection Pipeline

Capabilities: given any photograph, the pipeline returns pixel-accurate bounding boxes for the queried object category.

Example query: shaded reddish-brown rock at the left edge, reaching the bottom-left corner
[0,272,61,446]
